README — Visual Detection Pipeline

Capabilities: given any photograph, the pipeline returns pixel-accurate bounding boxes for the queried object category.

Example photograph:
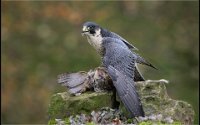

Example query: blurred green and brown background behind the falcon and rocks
[1,1,199,124]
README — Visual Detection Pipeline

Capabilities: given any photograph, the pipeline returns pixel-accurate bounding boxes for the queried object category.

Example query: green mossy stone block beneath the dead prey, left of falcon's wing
[48,92,111,119]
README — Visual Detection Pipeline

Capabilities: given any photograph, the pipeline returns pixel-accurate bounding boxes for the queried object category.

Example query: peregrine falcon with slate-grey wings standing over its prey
[82,22,155,117]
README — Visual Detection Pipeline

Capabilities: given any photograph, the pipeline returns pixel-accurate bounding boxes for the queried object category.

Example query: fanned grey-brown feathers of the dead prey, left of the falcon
[58,72,88,88]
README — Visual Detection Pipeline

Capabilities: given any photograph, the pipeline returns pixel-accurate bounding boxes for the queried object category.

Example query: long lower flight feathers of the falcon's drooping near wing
[108,66,144,117]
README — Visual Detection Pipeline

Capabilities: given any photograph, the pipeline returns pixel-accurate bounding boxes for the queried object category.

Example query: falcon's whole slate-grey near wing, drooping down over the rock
[103,38,144,116]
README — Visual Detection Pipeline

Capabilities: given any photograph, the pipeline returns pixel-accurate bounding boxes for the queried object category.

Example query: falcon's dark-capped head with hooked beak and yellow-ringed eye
[82,22,101,36]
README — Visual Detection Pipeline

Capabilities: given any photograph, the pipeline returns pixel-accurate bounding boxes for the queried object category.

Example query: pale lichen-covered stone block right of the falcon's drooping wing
[136,80,194,124]
